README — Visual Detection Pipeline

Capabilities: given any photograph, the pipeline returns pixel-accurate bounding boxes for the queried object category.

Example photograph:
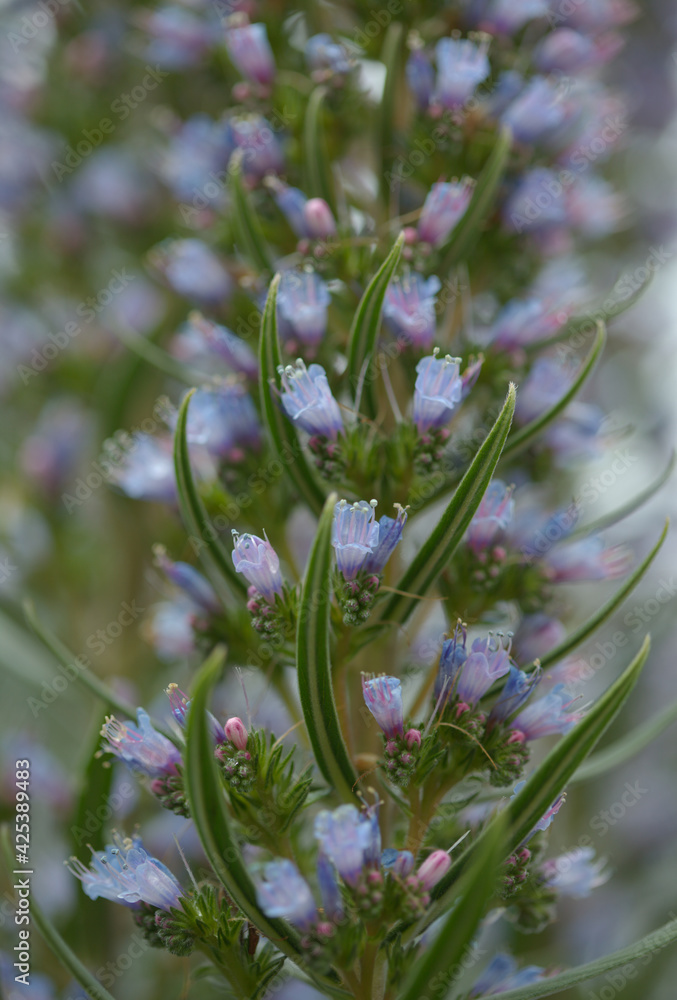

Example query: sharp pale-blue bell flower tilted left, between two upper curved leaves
[280,358,343,441]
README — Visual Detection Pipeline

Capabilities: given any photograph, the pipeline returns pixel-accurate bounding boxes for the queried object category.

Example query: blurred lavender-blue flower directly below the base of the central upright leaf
[315,806,381,887]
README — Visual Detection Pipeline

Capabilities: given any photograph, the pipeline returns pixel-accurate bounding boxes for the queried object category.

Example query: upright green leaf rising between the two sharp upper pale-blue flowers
[348,233,404,417]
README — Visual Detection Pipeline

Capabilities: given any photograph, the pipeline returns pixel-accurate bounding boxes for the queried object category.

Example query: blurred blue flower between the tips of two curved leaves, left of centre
[177,382,261,461]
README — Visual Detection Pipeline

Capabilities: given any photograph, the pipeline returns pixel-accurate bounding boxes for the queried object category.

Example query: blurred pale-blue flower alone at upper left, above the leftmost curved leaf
[151,239,233,306]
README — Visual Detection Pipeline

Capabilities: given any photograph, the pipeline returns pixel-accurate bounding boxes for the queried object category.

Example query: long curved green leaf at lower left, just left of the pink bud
[184,647,300,959]
